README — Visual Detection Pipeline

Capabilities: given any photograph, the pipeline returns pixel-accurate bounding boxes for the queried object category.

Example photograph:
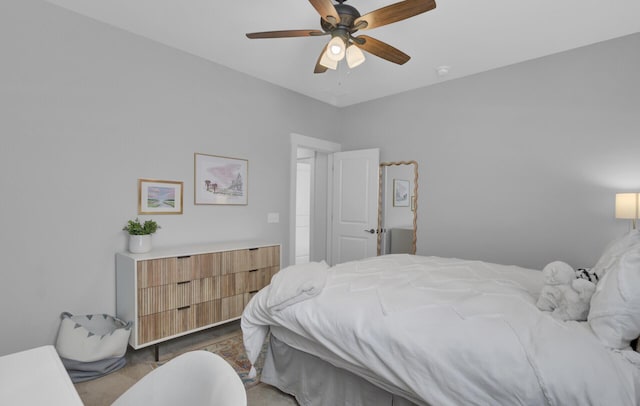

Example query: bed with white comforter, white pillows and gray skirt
[241,233,640,406]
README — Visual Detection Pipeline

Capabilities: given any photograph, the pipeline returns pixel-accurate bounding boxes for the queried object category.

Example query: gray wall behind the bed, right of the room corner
[341,34,640,268]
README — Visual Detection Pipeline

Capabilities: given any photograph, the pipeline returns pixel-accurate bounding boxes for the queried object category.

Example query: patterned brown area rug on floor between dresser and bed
[158,330,269,389]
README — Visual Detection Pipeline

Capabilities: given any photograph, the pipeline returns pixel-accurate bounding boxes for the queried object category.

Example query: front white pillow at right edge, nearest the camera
[588,244,640,349]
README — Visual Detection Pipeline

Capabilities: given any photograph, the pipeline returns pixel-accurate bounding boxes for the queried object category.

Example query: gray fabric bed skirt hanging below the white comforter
[260,334,416,406]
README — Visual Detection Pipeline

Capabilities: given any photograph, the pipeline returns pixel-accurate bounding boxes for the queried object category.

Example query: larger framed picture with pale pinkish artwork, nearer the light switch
[193,153,249,205]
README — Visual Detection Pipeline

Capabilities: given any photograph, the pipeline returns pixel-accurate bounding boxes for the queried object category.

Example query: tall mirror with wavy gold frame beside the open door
[378,161,418,255]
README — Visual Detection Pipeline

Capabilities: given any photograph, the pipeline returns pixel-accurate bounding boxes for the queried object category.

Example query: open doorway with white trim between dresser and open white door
[289,134,341,264]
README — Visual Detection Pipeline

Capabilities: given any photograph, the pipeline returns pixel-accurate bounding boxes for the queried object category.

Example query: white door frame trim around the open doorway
[289,133,342,265]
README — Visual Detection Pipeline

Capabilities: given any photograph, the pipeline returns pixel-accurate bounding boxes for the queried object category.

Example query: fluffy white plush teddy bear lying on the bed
[536,261,596,320]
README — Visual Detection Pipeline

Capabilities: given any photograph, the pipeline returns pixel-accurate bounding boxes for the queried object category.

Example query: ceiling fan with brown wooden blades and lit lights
[247,0,436,73]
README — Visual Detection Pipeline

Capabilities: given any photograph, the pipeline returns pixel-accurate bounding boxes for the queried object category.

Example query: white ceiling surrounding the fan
[47,0,640,107]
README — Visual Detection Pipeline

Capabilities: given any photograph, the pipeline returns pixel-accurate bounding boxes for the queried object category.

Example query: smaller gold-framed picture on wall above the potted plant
[138,179,183,214]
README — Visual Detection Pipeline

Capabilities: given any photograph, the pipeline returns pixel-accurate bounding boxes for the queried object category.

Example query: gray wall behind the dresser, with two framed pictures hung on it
[0,0,339,355]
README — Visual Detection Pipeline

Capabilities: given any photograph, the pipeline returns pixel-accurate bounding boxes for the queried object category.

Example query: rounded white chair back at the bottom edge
[112,351,247,406]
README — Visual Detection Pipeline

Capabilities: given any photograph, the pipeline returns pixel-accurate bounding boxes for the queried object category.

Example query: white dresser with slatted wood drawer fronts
[116,241,280,350]
